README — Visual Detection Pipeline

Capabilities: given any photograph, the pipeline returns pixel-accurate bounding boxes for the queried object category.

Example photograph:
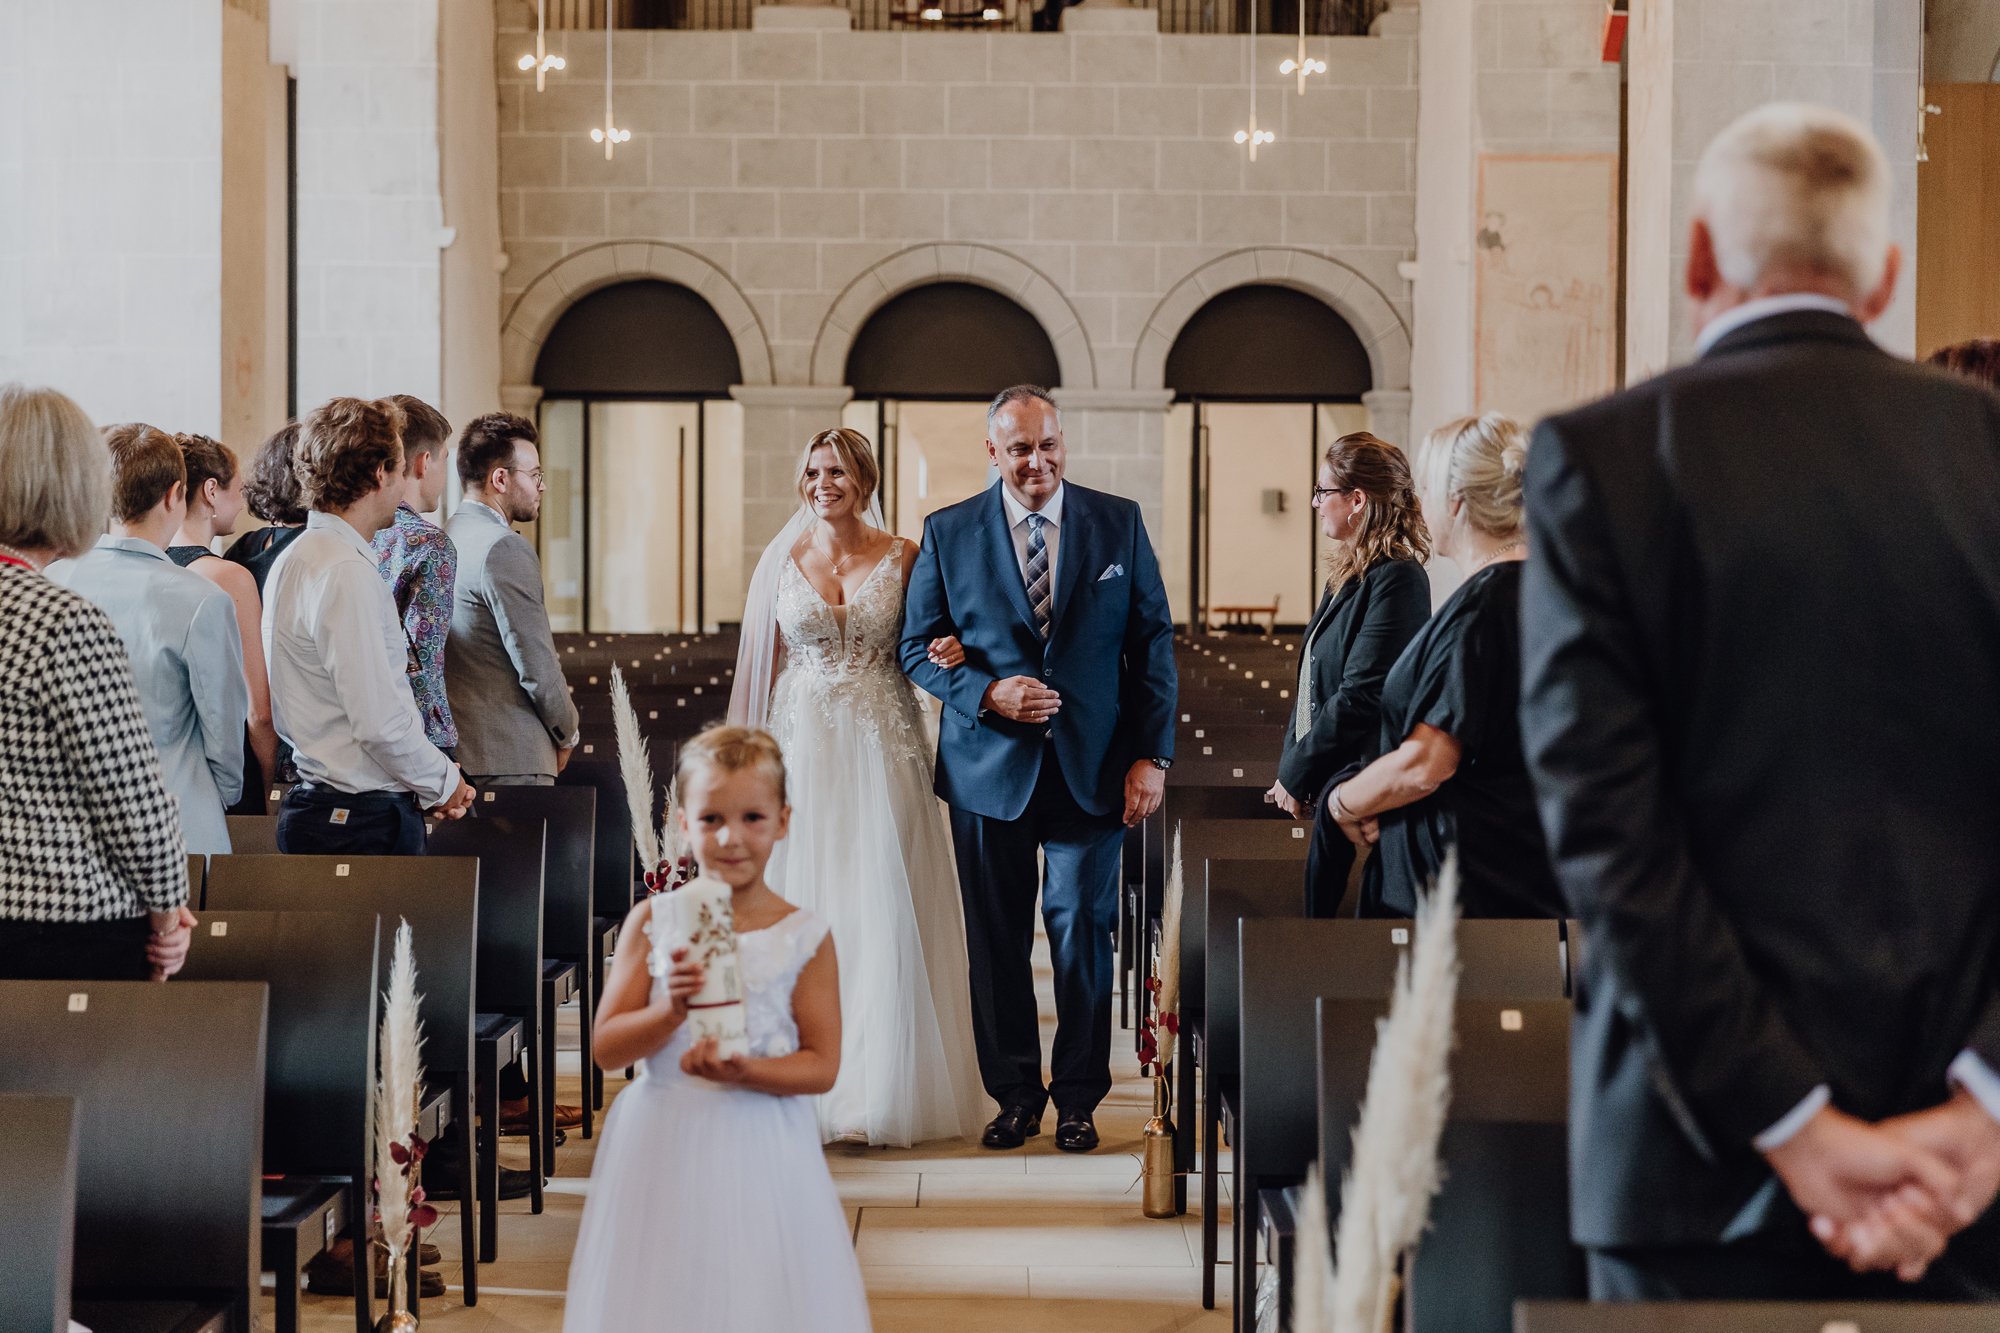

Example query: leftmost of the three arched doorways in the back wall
[534,278,742,632]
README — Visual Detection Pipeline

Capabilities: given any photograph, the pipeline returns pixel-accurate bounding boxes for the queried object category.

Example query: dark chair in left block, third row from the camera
[180,911,384,1333]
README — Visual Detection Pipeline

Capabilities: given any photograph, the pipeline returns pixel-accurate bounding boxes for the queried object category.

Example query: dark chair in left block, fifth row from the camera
[426,815,554,1263]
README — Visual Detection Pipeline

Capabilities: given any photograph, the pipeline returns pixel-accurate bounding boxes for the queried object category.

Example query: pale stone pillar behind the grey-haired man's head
[1626,0,1922,382]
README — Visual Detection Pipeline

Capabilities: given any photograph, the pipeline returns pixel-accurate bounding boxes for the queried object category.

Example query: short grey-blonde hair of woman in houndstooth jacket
[0,382,112,558]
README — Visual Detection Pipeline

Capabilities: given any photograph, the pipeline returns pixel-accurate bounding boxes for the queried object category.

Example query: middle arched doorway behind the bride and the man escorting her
[842,282,1062,536]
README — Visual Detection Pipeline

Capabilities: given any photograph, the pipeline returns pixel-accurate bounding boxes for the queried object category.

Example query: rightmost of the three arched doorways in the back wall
[1162,282,1374,624]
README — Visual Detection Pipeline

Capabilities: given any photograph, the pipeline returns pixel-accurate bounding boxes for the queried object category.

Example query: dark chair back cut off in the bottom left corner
[0,1093,78,1333]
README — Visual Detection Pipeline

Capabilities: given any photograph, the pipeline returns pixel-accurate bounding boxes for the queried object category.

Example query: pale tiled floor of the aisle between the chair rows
[264,928,1230,1333]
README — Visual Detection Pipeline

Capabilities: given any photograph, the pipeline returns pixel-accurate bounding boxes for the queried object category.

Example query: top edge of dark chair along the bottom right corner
[1514,1301,1996,1333]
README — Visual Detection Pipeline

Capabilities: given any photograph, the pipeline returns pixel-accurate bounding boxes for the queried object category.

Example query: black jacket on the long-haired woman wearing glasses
[1278,560,1430,803]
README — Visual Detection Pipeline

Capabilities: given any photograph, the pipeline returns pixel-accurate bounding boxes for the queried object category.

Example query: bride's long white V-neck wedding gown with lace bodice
[766,538,984,1147]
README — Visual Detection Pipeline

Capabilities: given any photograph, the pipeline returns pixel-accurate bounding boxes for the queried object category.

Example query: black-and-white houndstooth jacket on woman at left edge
[0,564,188,921]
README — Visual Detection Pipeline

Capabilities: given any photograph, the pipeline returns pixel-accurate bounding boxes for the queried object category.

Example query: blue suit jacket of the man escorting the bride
[902,482,1178,819]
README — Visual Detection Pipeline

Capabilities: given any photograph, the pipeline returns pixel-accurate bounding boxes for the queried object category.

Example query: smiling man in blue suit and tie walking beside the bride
[902,384,1178,1153]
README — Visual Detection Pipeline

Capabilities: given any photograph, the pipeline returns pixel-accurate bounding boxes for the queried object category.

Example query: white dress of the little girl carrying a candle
[562,899,870,1333]
